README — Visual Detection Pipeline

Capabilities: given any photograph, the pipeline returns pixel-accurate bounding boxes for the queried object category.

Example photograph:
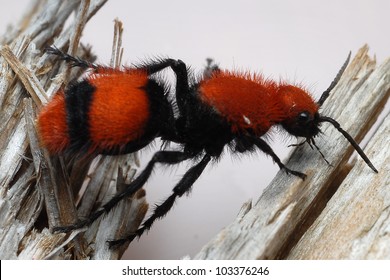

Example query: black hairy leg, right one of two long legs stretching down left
[108,154,211,246]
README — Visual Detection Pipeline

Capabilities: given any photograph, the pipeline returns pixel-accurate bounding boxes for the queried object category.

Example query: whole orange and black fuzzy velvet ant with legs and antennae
[38,48,378,245]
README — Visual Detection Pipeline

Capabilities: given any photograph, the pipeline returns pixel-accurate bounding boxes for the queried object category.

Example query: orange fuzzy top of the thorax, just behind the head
[199,72,284,135]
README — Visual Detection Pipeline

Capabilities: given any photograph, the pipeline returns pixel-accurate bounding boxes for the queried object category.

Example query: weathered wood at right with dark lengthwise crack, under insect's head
[195,46,390,259]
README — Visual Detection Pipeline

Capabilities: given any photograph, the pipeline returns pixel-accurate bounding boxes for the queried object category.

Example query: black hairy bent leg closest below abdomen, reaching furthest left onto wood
[54,151,191,232]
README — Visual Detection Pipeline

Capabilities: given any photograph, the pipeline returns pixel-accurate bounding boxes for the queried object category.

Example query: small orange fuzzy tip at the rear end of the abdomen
[37,92,70,154]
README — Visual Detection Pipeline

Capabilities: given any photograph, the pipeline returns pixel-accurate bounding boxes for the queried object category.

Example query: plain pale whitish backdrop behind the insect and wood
[0,0,390,259]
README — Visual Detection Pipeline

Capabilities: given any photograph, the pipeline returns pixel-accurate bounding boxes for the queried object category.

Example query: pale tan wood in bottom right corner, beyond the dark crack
[288,112,390,259]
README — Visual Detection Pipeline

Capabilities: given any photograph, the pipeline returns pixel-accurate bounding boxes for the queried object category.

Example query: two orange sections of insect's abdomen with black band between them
[38,70,150,154]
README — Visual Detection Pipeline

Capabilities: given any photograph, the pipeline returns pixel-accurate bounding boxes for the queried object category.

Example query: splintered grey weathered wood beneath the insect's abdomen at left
[0,0,148,259]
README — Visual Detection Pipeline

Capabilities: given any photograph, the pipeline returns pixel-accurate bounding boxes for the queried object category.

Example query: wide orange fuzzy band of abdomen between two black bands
[88,71,150,149]
